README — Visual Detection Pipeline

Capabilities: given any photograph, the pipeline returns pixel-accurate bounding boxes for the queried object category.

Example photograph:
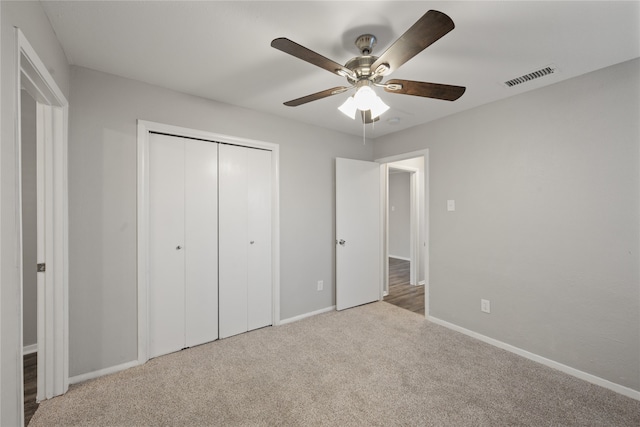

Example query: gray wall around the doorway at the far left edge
[0,1,69,426]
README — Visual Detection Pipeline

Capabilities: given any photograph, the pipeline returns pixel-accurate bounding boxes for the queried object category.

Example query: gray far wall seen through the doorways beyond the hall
[388,172,411,259]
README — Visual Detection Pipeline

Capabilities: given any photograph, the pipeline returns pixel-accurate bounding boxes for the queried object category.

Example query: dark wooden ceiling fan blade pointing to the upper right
[371,10,455,75]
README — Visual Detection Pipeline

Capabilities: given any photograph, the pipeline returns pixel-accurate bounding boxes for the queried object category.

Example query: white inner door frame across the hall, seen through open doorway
[383,162,422,296]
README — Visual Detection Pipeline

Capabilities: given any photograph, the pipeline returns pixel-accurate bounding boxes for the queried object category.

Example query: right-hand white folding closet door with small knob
[219,145,272,338]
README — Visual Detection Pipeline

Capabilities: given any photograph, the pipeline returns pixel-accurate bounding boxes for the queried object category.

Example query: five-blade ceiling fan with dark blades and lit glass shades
[271,10,466,123]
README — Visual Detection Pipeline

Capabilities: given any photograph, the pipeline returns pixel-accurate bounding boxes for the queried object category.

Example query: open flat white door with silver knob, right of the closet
[336,158,381,310]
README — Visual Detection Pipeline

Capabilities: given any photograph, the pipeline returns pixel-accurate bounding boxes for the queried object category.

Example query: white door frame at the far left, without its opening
[14,28,69,412]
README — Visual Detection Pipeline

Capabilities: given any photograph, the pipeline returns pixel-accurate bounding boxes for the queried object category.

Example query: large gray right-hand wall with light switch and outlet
[374,59,640,390]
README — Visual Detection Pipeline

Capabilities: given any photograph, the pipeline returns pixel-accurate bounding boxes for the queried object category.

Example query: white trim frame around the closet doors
[137,120,280,364]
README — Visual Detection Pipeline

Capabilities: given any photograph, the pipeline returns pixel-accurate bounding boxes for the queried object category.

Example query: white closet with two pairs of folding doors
[148,133,272,357]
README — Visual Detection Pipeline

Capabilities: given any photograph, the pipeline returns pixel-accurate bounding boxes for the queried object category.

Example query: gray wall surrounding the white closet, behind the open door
[69,67,373,376]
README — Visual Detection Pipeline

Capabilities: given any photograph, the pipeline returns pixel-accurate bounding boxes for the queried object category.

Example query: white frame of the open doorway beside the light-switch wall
[376,149,430,318]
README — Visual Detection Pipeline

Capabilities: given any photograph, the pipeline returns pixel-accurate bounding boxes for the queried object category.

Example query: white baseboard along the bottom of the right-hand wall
[427,316,640,400]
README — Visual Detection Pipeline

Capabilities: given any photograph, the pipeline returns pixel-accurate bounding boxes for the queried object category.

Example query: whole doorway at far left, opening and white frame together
[14,28,69,424]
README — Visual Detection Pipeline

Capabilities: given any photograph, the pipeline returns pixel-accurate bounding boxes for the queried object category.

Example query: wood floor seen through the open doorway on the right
[384,258,424,316]
